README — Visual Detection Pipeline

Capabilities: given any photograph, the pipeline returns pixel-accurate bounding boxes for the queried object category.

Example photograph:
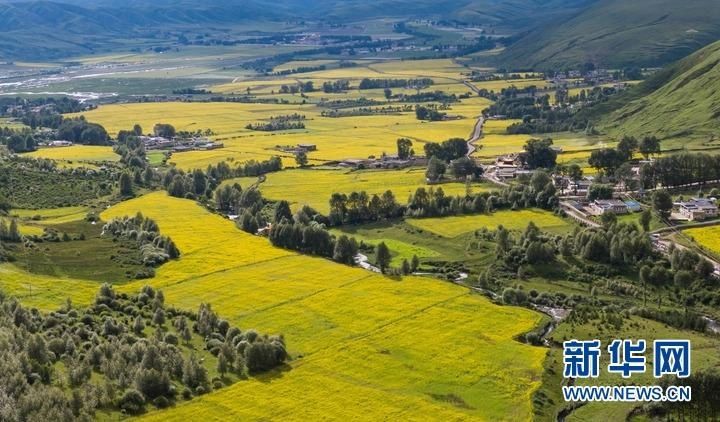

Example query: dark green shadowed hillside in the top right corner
[498,0,720,69]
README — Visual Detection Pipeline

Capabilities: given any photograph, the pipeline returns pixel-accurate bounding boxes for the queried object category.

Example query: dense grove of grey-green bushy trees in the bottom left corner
[0,285,287,421]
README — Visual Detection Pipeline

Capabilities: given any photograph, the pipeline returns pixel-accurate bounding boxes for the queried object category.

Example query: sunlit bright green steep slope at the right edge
[601,42,720,143]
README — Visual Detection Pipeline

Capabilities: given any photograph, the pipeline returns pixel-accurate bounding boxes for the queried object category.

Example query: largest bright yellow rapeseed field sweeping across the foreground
[95,193,545,420]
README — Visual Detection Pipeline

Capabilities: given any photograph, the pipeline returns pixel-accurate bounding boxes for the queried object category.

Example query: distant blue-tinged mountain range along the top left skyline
[0,0,591,60]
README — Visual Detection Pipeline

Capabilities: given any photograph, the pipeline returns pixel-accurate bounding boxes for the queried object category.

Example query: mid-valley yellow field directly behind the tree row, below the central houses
[225,168,493,213]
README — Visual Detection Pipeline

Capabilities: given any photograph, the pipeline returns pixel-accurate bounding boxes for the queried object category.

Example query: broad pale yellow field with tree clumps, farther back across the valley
[74,98,488,169]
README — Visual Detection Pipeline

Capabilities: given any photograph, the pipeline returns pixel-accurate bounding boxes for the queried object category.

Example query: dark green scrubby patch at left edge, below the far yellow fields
[0,156,115,209]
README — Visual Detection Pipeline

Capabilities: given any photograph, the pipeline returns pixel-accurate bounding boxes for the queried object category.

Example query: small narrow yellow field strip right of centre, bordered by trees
[407,210,571,237]
